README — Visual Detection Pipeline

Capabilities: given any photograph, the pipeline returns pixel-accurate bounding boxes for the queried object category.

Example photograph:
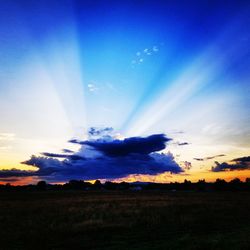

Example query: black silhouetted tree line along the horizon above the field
[0,178,250,192]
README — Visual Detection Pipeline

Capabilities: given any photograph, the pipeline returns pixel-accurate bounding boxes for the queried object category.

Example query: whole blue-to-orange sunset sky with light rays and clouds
[0,0,250,184]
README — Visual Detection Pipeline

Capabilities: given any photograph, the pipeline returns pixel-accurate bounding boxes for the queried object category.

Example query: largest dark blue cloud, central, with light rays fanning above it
[0,132,183,182]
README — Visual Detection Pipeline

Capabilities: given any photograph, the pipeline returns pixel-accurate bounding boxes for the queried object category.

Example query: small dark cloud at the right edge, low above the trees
[211,156,250,172]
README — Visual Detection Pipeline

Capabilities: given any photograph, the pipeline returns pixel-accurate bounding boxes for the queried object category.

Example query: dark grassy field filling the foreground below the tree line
[0,191,250,250]
